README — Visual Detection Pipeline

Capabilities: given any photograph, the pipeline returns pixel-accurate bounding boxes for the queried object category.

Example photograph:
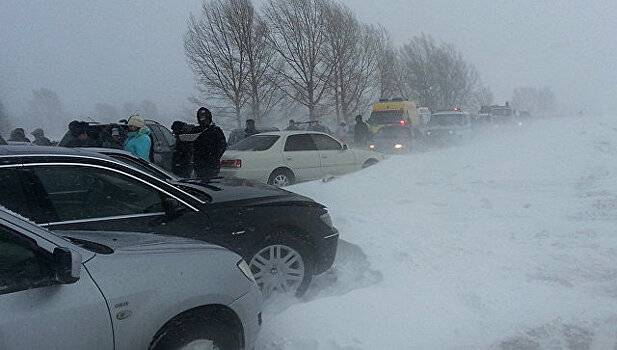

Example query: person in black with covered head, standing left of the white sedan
[193,107,227,179]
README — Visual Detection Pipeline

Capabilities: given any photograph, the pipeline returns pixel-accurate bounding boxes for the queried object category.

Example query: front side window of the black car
[33,166,165,221]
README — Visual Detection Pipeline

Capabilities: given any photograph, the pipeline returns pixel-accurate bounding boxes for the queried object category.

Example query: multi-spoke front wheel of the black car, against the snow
[249,242,313,298]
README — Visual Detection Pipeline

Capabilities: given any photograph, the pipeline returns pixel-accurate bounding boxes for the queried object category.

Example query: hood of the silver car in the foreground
[54,231,225,254]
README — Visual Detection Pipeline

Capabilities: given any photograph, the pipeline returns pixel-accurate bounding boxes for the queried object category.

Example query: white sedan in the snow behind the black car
[221,131,384,187]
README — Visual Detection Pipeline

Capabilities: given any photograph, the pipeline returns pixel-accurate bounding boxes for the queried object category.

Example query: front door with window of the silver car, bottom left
[0,220,114,350]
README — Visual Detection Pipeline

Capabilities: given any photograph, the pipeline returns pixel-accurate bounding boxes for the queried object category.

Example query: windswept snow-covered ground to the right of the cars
[257,118,617,350]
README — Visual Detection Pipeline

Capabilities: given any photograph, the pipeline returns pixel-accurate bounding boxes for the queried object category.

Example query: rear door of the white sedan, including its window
[283,134,322,181]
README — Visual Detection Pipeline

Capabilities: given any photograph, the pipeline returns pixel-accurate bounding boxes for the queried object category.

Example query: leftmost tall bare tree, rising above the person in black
[184,0,247,127]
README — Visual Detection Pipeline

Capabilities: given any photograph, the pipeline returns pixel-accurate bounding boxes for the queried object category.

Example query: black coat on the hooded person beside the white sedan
[193,124,227,170]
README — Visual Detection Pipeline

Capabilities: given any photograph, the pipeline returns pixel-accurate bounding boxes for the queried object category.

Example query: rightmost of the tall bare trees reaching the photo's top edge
[325,3,381,122]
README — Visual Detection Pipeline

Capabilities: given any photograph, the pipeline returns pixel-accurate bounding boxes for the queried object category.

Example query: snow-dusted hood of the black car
[172,178,318,205]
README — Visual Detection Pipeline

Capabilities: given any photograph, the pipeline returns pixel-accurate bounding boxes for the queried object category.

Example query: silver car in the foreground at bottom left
[0,209,262,350]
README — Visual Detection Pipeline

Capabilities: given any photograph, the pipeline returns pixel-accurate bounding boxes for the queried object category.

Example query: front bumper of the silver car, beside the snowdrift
[230,287,263,350]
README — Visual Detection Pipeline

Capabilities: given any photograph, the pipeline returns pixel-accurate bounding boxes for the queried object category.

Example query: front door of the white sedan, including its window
[311,134,356,176]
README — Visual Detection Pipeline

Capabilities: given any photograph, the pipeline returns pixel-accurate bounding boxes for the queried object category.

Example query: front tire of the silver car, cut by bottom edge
[150,313,241,350]
